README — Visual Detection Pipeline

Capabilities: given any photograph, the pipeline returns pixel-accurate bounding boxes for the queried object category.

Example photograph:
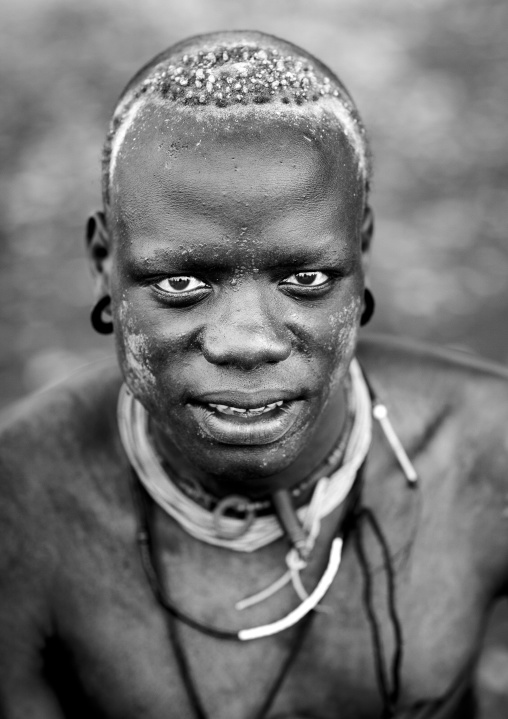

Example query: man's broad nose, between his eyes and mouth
[201,289,291,370]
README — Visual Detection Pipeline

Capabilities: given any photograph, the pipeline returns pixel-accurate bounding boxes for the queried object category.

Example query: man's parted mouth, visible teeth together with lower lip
[188,399,303,445]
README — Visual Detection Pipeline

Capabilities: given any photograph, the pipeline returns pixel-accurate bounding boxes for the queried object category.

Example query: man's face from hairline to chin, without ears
[110,109,363,490]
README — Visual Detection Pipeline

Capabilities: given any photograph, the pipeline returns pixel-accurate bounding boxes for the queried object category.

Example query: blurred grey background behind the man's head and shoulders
[0,0,508,719]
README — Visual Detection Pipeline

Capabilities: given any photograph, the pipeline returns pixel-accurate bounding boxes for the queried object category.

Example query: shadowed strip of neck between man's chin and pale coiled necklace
[151,379,349,501]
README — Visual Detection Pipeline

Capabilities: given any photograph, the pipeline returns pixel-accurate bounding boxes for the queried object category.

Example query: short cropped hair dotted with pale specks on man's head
[102,31,372,206]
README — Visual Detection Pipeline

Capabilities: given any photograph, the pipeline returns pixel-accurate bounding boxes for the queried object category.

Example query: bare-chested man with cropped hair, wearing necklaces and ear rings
[0,33,508,719]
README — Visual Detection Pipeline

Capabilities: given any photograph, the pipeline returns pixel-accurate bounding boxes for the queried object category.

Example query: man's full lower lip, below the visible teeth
[188,401,301,445]
